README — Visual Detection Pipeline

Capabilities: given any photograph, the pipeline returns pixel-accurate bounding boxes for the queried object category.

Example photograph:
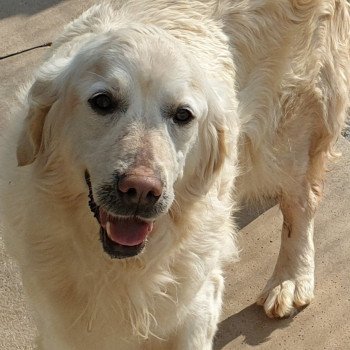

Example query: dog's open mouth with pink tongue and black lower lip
[99,208,153,259]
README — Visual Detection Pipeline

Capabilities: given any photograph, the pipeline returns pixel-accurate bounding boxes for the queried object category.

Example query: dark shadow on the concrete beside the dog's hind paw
[213,304,293,350]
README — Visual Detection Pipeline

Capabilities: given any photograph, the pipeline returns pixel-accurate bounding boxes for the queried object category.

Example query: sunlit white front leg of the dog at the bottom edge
[172,270,224,350]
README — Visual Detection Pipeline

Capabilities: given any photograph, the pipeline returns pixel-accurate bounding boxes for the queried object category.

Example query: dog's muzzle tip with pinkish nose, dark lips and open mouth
[85,172,162,259]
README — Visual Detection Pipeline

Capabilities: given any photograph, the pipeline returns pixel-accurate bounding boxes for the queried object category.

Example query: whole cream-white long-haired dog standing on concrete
[1,0,350,350]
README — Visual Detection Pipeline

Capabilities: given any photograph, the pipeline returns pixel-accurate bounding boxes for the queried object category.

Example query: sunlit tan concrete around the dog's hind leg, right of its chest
[215,139,350,350]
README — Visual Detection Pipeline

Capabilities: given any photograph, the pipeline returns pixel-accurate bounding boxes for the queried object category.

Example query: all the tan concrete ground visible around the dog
[0,0,350,350]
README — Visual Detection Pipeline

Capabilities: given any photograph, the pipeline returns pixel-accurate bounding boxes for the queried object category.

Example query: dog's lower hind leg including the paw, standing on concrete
[257,189,317,317]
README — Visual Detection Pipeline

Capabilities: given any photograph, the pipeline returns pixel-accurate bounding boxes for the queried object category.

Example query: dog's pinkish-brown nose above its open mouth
[118,174,163,205]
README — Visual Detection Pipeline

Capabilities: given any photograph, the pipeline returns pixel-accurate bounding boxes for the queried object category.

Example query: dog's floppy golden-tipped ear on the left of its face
[17,67,61,166]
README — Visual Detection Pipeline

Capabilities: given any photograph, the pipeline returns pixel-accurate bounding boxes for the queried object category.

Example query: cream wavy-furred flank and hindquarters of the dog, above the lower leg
[221,0,350,199]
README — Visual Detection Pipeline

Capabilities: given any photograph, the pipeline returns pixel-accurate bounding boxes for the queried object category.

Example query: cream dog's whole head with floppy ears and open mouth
[17,27,233,258]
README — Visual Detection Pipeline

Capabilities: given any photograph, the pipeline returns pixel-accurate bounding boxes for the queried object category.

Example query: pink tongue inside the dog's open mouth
[100,209,153,247]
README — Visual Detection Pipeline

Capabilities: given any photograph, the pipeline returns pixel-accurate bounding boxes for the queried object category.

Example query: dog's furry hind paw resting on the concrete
[257,277,314,318]
